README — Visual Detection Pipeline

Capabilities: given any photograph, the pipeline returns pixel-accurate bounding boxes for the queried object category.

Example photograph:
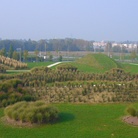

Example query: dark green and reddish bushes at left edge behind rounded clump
[0,79,35,107]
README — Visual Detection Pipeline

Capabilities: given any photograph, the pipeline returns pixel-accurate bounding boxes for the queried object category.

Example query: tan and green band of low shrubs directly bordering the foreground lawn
[32,81,138,103]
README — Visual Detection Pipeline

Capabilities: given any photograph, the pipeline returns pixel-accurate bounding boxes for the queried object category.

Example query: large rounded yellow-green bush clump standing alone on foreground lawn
[4,101,59,124]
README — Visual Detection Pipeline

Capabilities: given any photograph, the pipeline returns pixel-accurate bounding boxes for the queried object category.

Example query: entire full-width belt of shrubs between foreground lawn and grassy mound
[0,65,138,106]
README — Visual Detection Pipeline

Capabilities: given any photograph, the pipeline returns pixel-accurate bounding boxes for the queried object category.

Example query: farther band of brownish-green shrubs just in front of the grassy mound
[18,67,138,87]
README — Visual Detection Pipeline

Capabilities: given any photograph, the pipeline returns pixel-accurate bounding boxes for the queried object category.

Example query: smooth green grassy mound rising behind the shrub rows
[70,54,121,73]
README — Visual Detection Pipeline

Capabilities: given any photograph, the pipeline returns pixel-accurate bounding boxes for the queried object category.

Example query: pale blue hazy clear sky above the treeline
[0,0,138,41]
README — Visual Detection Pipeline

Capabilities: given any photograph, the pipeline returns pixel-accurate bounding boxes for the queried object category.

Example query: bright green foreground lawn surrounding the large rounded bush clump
[0,103,138,138]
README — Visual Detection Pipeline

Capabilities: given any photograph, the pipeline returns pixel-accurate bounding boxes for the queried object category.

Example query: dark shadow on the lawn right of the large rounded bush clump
[58,112,75,123]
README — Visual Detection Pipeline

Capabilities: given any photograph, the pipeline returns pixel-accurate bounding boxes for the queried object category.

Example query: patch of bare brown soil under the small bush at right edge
[123,116,138,126]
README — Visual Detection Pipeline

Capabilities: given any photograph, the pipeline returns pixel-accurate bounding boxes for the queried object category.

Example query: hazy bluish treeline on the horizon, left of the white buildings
[0,38,93,51]
